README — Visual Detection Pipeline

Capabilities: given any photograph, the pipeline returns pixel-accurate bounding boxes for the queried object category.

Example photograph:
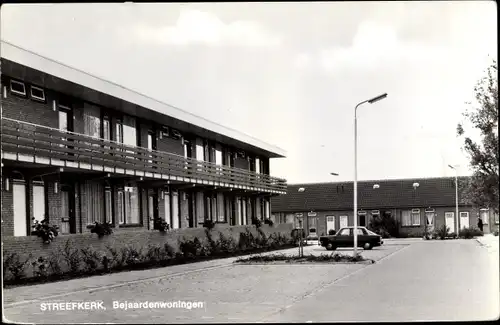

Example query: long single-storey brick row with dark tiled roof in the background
[271,177,499,236]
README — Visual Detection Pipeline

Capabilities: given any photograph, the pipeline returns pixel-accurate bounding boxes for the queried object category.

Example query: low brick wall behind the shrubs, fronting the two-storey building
[3,224,292,277]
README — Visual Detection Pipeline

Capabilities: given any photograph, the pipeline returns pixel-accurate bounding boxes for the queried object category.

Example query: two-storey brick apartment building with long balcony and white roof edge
[1,41,286,236]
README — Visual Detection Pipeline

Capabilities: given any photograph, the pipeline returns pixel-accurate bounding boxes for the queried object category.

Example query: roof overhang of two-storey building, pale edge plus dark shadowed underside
[0,40,286,158]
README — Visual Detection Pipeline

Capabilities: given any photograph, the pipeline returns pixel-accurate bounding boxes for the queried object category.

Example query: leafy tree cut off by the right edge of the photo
[457,60,499,213]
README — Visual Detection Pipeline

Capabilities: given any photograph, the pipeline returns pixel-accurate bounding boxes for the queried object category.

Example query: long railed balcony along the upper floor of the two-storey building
[1,118,286,194]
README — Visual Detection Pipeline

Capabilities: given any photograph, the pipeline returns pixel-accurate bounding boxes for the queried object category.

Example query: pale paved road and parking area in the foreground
[4,240,500,323]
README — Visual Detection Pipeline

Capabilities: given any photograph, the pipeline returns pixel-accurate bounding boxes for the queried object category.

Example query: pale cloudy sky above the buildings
[0,1,497,183]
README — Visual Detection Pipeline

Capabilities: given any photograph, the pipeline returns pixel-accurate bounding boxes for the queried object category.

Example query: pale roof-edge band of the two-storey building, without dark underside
[0,40,286,157]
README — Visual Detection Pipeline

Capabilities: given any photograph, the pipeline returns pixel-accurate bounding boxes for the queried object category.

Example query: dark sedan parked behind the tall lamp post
[319,227,384,250]
